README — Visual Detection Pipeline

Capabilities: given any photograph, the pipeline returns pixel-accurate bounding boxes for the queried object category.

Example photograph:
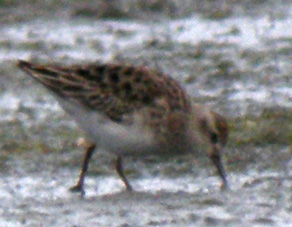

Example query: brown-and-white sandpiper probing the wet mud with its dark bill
[16,60,229,195]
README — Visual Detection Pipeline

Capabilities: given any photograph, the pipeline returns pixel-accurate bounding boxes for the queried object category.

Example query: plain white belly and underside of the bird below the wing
[58,98,156,154]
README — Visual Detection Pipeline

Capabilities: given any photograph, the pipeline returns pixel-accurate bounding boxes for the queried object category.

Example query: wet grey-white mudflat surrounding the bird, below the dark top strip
[0,0,292,226]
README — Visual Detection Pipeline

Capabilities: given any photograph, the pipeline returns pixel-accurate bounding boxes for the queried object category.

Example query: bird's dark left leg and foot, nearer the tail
[70,143,96,195]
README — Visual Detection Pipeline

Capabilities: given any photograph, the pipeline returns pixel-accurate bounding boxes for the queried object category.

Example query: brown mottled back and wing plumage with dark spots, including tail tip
[18,61,190,121]
